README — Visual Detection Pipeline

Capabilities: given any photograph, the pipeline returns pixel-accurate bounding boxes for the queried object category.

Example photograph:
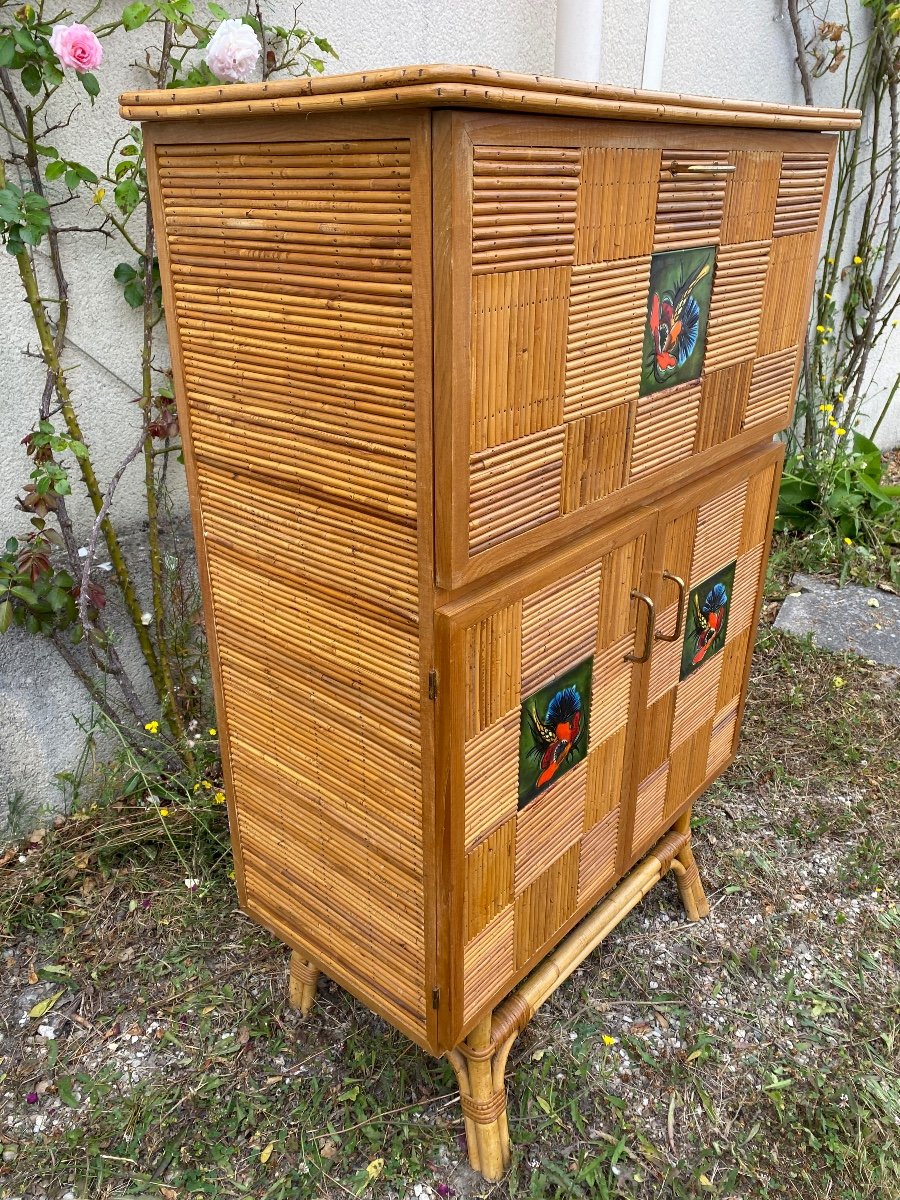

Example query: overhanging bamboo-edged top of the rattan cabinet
[120,65,859,131]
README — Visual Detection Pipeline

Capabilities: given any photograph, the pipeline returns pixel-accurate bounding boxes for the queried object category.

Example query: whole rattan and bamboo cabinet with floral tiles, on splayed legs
[122,67,858,1177]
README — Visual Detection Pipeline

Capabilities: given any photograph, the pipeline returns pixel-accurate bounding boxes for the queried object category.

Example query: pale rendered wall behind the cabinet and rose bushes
[0,0,900,828]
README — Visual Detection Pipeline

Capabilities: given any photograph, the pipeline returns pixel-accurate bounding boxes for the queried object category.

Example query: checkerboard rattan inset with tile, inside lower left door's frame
[461,536,644,1020]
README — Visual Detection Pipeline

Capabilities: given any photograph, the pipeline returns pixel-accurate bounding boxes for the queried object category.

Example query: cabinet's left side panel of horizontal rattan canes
[157,139,426,1032]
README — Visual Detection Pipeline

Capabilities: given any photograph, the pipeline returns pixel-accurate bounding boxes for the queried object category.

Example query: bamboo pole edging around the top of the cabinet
[120,64,860,128]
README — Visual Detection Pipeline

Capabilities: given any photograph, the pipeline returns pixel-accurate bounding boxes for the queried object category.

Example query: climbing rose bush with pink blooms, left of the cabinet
[0,0,334,769]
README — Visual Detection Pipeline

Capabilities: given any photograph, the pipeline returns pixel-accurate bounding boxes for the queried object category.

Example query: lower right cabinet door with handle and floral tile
[629,445,784,862]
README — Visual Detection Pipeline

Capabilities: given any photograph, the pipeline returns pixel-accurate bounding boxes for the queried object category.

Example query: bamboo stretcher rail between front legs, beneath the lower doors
[458,833,698,1060]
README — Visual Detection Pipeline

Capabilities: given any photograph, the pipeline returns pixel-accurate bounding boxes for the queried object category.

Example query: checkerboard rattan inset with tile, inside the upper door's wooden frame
[468,134,829,560]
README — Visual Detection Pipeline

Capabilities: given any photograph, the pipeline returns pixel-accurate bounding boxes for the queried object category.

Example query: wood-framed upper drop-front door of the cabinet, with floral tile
[433,112,835,588]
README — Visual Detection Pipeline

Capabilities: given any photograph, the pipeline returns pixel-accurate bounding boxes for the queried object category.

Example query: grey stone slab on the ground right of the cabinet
[775,575,900,667]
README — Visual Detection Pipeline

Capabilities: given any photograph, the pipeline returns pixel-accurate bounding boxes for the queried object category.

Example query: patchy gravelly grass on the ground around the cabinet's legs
[0,629,900,1200]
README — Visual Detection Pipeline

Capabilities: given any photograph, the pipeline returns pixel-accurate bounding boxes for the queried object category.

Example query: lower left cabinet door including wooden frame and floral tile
[438,510,654,1045]
